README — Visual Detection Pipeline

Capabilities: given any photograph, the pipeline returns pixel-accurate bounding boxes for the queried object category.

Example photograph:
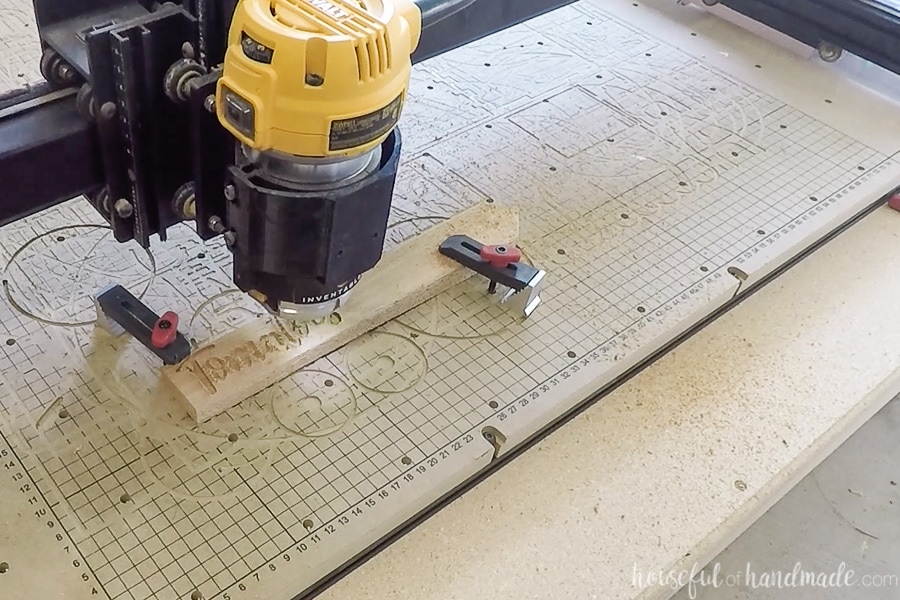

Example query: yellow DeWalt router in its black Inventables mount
[216,0,421,320]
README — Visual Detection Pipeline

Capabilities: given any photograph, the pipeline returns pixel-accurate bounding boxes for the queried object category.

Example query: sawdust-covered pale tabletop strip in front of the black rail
[312,208,900,600]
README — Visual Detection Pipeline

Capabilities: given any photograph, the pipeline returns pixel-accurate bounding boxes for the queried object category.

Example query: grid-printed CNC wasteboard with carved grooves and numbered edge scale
[0,0,900,600]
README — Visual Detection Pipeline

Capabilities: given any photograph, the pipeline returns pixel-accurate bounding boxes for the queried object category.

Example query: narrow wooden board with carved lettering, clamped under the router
[162,204,519,423]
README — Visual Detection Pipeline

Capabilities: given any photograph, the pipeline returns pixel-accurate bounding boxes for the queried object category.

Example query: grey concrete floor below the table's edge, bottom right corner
[675,397,900,600]
